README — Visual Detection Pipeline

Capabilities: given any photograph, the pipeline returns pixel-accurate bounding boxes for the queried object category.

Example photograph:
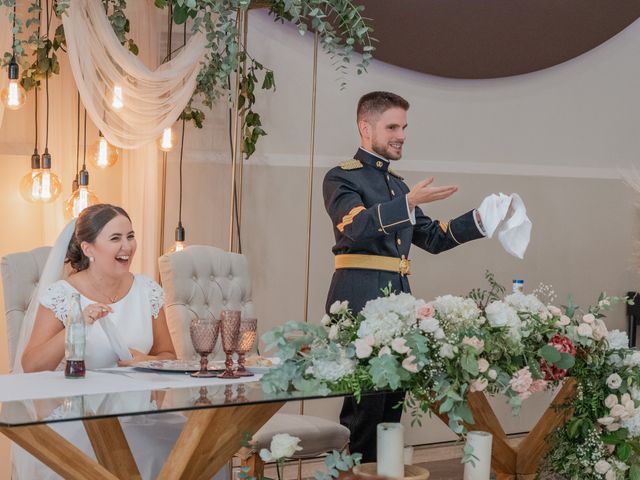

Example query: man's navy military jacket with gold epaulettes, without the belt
[323,149,483,313]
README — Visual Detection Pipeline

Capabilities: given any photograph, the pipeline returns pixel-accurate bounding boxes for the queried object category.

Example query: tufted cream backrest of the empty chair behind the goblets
[158,245,255,359]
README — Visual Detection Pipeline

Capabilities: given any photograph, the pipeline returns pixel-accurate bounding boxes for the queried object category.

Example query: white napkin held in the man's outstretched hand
[478,193,532,258]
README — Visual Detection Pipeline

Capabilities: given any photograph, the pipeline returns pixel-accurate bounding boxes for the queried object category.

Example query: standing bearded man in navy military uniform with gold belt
[323,92,484,462]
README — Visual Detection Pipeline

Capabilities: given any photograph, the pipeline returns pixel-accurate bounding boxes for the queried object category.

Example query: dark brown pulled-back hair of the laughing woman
[65,203,131,272]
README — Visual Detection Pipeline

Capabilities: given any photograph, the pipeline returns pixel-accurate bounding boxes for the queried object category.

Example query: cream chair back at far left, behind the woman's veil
[0,247,51,369]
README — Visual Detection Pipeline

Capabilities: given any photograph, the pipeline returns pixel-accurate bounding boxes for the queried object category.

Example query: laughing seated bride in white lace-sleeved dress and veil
[13,204,224,479]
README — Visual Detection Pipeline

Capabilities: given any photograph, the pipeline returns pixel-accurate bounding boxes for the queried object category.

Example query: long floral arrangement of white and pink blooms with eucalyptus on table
[262,273,640,474]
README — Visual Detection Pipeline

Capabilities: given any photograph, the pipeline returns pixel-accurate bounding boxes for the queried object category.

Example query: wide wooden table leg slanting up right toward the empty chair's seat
[158,402,284,480]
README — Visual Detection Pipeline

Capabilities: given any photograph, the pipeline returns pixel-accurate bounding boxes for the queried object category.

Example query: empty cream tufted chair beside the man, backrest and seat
[159,245,349,478]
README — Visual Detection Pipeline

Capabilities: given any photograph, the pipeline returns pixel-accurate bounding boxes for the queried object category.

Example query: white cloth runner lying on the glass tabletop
[0,368,262,402]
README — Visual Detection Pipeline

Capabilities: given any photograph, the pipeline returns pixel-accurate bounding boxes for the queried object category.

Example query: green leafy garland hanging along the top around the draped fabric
[0,0,374,158]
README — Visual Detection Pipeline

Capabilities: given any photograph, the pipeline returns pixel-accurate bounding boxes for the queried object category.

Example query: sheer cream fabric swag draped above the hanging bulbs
[63,0,205,149]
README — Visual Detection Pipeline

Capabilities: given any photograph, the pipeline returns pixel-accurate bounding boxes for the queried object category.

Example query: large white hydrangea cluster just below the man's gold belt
[358,293,424,346]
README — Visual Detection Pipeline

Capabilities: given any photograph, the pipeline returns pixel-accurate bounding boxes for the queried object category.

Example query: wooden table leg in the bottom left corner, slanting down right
[0,424,117,480]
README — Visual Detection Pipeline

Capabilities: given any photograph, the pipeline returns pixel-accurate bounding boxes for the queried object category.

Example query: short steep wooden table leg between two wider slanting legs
[82,417,140,480]
